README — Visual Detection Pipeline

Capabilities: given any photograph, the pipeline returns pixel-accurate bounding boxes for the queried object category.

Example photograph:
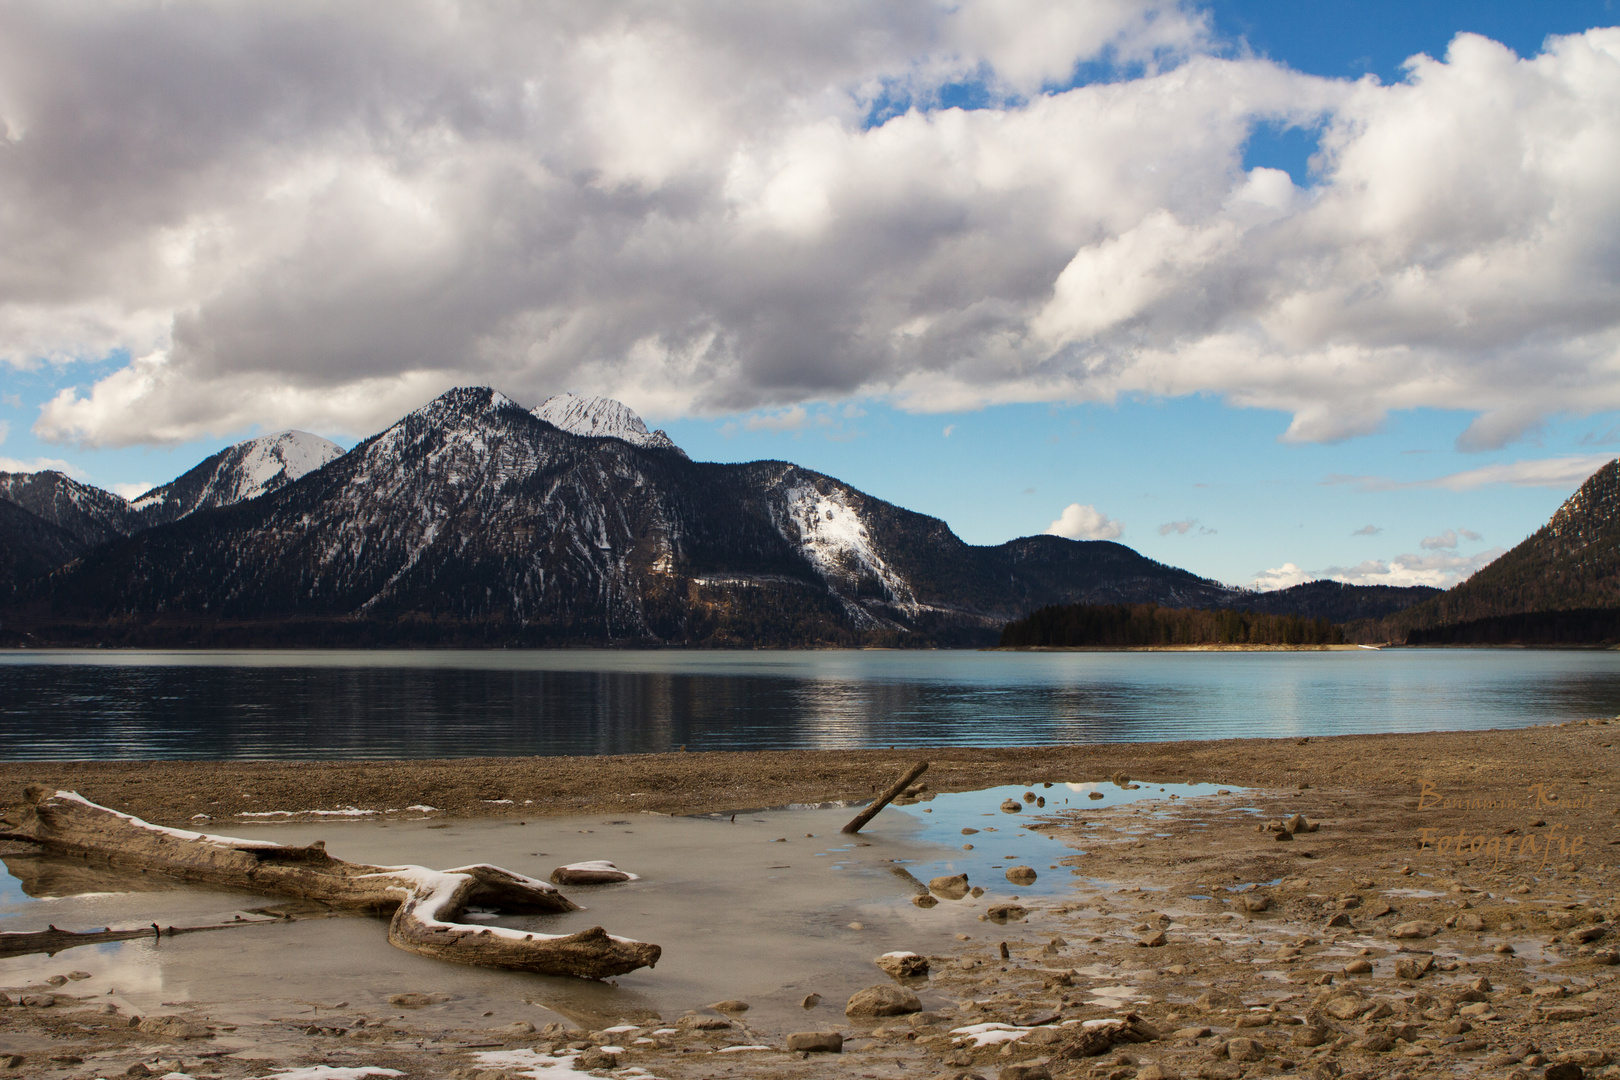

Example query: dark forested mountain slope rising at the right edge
[1353,461,1620,643]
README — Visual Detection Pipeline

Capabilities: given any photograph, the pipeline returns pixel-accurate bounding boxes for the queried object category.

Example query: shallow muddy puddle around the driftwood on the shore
[0,782,1237,1031]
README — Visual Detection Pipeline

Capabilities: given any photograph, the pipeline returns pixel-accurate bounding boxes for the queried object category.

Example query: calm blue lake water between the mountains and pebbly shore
[0,649,1620,761]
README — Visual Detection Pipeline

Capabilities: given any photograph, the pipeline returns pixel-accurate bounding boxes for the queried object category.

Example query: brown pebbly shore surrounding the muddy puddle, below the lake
[0,721,1620,1080]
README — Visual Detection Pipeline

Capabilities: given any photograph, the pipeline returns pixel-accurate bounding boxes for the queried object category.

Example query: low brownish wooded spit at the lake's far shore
[1001,604,1345,648]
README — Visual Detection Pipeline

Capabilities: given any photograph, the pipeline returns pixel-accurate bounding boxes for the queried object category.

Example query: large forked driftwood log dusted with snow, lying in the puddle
[0,784,663,978]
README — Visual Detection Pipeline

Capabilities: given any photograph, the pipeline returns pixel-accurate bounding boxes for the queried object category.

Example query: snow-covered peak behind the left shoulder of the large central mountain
[130,431,343,526]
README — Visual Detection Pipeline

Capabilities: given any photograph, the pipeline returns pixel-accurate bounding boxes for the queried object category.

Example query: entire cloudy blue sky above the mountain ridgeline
[0,0,1620,588]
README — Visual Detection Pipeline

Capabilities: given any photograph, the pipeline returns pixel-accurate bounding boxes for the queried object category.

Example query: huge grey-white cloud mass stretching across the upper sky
[0,8,1620,446]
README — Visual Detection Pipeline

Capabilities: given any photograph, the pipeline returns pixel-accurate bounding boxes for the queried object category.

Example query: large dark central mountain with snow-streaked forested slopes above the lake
[9,389,1234,644]
